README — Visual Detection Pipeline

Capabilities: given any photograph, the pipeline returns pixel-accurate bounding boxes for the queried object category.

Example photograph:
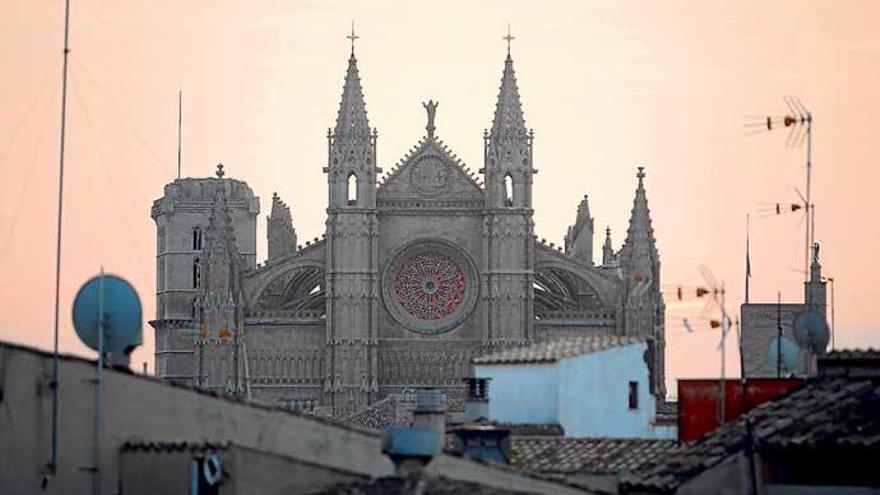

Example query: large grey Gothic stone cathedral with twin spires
[151,42,665,416]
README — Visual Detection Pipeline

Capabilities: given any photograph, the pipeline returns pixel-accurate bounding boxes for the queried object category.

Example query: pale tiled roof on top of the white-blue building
[474,335,645,364]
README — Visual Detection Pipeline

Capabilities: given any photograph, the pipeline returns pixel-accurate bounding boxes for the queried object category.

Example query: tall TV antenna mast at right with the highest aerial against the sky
[745,95,815,280]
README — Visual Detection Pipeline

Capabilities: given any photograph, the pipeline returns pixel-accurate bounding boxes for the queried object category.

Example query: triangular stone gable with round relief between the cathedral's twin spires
[377,137,483,200]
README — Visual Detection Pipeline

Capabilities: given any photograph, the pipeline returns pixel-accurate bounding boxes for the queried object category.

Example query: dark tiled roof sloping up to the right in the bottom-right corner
[620,378,880,493]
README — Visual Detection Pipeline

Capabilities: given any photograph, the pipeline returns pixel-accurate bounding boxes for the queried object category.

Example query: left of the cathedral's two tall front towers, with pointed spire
[323,30,381,415]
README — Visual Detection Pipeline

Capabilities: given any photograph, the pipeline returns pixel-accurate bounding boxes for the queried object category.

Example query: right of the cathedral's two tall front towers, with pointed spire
[481,33,537,345]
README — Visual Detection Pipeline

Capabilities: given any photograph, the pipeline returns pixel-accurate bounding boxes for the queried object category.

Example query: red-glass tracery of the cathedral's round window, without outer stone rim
[394,252,465,321]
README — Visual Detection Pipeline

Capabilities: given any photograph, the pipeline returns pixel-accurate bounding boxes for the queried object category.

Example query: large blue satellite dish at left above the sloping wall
[73,275,143,356]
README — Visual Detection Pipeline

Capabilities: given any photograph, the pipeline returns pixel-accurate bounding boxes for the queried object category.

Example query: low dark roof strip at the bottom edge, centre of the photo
[304,475,527,495]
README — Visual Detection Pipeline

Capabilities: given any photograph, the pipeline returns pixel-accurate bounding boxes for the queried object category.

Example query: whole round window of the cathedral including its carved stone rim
[382,240,478,334]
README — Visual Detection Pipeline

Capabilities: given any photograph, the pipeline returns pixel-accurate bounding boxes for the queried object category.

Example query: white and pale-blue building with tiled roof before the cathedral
[474,336,677,438]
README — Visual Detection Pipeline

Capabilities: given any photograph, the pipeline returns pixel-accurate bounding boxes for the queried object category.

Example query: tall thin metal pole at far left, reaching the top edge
[48,0,70,476]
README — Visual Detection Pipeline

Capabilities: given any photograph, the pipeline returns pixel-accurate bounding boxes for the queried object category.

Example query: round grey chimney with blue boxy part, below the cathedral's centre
[382,388,446,476]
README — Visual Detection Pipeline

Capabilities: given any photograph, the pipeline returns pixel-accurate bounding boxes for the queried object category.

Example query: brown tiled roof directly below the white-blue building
[510,437,675,475]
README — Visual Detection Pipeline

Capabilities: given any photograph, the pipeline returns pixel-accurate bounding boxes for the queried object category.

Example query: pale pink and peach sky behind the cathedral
[0,0,880,396]
